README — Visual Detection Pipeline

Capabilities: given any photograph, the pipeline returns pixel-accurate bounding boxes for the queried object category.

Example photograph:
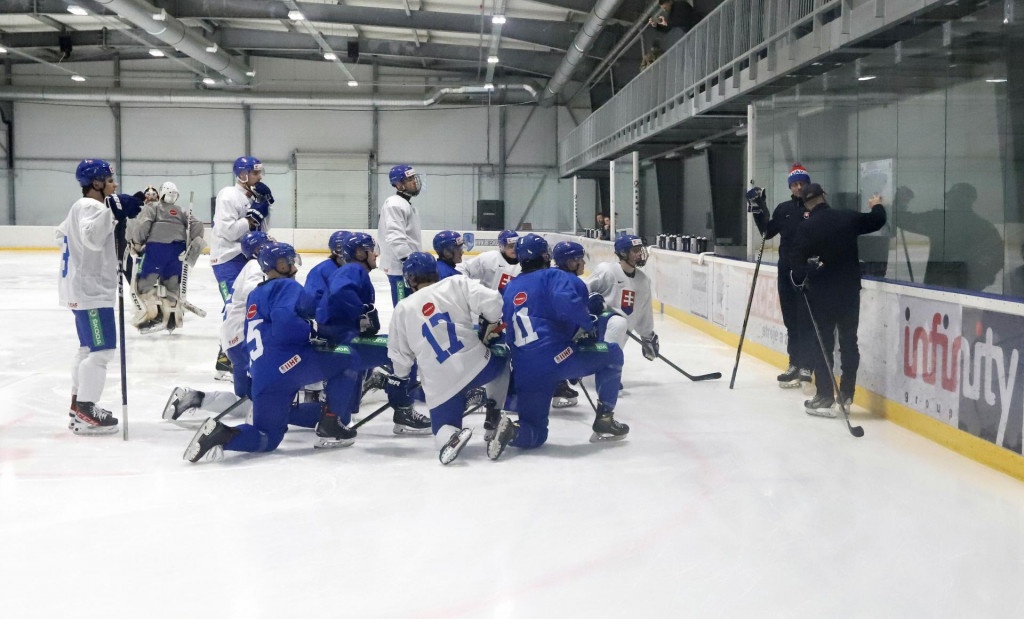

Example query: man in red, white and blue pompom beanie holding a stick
[746,163,815,388]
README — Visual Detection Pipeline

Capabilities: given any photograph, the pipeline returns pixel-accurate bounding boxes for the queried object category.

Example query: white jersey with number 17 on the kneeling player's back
[387,276,502,408]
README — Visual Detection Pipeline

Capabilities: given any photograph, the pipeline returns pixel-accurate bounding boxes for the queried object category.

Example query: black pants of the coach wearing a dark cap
[800,290,860,397]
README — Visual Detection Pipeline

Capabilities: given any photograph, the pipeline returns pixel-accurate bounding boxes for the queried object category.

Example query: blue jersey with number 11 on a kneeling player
[502,269,593,354]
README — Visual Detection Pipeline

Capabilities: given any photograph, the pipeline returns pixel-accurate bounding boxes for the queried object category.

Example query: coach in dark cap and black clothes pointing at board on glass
[791,182,886,417]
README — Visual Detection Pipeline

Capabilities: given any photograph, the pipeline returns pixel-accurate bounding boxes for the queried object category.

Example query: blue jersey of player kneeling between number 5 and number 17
[316,262,377,343]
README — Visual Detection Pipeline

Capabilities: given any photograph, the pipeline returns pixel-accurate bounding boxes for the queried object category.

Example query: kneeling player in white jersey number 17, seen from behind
[387,252,509,464]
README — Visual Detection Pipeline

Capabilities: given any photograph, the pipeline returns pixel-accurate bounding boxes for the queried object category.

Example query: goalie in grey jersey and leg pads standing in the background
[128,180,203,333]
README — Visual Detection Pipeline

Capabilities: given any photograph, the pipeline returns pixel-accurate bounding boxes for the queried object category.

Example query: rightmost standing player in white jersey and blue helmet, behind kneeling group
[377,165,423,305]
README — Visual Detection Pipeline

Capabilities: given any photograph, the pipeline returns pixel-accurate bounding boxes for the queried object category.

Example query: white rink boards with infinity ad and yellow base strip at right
[545,234,1024,479]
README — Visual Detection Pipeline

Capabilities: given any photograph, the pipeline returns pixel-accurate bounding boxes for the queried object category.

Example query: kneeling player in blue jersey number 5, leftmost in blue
[184,243,358,462]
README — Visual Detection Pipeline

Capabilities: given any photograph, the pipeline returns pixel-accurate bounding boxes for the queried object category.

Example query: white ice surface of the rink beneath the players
[0,251,1024,619]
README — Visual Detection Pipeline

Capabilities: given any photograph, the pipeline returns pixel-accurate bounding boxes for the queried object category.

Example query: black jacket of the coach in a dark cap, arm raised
[793,204,886,300]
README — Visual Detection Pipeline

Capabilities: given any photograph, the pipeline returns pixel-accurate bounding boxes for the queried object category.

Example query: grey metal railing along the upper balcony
[558,0,943,175]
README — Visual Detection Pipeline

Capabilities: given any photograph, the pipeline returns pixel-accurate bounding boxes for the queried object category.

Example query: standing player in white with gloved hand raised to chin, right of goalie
[210,157,273,374]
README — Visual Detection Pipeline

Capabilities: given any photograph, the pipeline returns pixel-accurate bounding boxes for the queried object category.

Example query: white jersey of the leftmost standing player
[55,198,118,310]
